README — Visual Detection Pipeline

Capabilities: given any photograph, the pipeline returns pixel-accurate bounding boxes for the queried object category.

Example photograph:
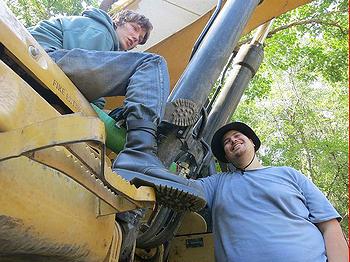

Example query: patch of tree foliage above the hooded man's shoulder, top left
[5,0,98,27]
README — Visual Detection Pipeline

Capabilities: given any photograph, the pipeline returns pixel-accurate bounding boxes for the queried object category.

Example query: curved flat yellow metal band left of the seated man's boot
[0,114,105,162]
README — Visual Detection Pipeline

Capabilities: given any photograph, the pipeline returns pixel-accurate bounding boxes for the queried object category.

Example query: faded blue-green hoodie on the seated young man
[28,8,119,51]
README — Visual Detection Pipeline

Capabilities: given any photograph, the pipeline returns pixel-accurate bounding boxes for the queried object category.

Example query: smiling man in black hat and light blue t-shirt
[195,122,348,262]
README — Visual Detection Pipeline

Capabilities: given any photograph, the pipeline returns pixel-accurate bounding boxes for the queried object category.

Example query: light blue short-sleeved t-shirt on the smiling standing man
[196,167,340,262]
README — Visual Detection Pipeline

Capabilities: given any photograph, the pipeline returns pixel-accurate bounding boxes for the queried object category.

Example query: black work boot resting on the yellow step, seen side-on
[113,120,206,211]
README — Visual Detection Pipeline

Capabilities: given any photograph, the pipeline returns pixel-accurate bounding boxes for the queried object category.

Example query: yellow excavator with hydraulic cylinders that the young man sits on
[0,0,310,262]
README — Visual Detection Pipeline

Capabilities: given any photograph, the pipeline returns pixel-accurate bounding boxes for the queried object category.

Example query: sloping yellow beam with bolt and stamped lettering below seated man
[0,1,96,116]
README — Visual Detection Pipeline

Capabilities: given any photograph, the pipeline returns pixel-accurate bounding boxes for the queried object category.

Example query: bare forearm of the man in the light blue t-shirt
[316,219,349,262]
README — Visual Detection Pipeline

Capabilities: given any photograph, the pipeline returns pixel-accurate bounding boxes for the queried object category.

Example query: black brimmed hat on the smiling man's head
[211,122,261,163]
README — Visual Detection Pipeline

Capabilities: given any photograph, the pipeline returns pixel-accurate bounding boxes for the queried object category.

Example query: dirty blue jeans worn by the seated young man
[48,49,170,124]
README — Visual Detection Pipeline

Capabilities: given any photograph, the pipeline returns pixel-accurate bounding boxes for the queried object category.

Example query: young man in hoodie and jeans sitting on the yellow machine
[29,8,205,210]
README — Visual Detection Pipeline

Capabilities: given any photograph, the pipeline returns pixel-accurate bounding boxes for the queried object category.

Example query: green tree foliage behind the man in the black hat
[233,0,348,232]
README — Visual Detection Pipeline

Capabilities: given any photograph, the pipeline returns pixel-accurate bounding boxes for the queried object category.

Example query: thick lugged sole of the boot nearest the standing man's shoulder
[113,169,206,212]
